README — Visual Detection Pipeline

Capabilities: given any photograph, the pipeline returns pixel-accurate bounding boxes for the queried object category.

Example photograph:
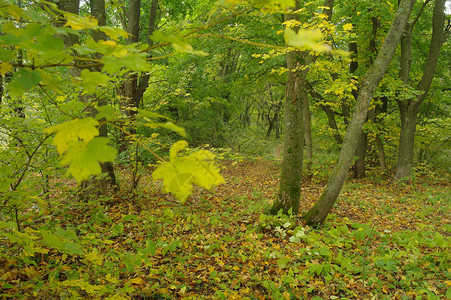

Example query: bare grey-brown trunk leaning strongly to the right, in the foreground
[303,0,415,225]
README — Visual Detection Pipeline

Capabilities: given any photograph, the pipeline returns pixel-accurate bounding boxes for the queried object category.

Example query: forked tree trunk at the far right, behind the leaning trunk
[395,0,446,180]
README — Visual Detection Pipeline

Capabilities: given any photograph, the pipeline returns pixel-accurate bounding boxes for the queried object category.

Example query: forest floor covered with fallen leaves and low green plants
[0,160,451,299]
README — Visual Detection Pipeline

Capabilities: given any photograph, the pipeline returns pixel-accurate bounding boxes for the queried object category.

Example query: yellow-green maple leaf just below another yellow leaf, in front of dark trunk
[61,137,117,183]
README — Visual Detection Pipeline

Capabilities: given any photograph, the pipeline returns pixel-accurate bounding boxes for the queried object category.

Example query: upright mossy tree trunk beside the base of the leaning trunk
[270,1,307,215]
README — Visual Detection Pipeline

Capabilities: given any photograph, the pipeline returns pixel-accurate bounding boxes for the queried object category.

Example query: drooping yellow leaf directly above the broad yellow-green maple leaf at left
[44,117,99,154]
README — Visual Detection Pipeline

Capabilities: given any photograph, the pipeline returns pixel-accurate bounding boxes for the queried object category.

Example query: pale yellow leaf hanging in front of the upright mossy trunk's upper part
[284,27,330,52]
